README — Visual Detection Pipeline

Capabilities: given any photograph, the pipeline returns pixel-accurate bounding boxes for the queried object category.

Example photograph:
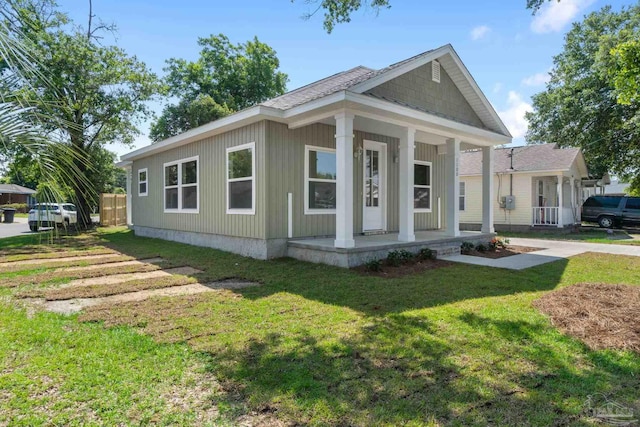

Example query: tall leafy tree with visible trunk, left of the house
[1,0,159,226]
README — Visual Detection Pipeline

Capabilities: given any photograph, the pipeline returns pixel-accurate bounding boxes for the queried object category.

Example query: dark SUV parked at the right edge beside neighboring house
[582,196,640,228]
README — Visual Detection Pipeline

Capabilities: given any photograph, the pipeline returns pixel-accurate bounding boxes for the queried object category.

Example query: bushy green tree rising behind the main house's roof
[149,34,288,141]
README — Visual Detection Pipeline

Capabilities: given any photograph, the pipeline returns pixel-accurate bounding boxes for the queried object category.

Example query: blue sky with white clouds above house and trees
[59,0,629,158]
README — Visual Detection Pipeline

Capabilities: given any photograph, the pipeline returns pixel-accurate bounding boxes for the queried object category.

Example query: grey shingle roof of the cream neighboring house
[460,144,587,177]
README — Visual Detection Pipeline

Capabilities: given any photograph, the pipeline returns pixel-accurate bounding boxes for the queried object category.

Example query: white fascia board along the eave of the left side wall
[121,105,282,160]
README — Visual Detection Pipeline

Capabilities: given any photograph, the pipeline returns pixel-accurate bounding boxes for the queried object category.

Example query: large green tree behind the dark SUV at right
[527,5,640,189]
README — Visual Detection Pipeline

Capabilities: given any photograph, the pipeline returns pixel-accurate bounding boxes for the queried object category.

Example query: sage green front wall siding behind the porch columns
[265,121,445,238]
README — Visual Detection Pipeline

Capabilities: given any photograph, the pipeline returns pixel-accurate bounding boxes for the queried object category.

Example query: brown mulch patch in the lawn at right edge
[533,283,640,353]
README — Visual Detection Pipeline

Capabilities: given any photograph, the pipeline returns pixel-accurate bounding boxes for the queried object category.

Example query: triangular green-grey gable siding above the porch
[366,62,485,128]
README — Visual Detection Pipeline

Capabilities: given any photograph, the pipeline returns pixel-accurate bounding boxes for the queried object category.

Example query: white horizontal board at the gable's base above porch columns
[346,92,512,146]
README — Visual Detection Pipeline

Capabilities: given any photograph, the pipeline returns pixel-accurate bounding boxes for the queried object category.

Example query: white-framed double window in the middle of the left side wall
[162,156,200,213]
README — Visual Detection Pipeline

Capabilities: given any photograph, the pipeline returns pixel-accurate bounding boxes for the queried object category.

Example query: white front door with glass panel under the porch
[362,141,387,231]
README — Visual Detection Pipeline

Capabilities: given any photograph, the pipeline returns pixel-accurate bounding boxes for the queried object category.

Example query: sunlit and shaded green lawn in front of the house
[0,229,640,426]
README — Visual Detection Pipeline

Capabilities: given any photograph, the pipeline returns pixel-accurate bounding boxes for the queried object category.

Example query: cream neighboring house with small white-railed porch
[459,144,588,231]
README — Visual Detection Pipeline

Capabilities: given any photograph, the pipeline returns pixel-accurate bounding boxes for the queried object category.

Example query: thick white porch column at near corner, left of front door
[334,111,356,248]
